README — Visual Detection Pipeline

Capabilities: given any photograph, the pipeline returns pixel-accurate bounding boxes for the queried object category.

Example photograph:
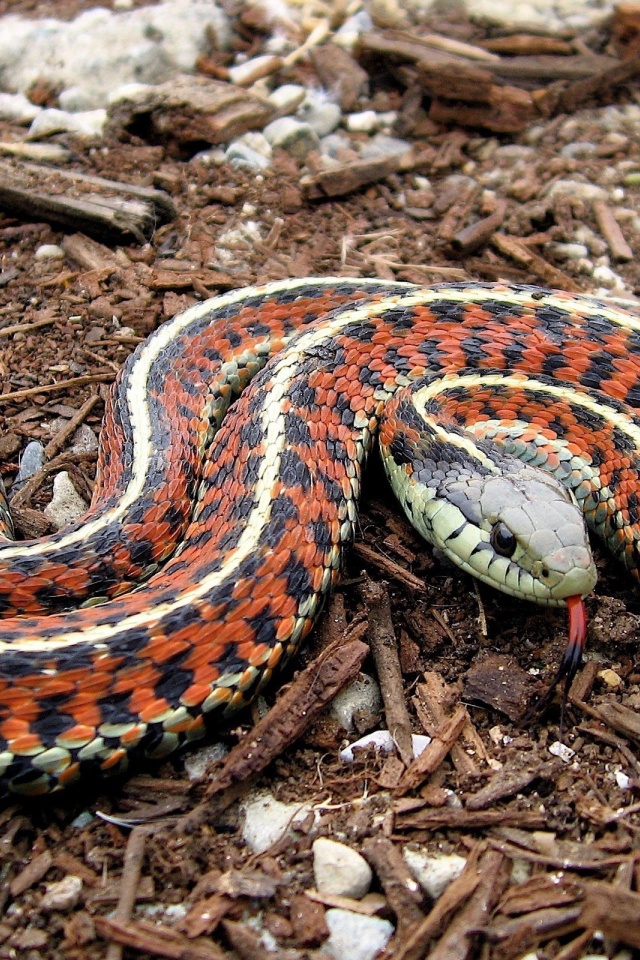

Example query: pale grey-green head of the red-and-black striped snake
[381,410,596,605]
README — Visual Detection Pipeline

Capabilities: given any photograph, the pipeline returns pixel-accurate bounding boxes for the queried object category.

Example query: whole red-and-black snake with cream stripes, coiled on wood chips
[0,278,640,795]
